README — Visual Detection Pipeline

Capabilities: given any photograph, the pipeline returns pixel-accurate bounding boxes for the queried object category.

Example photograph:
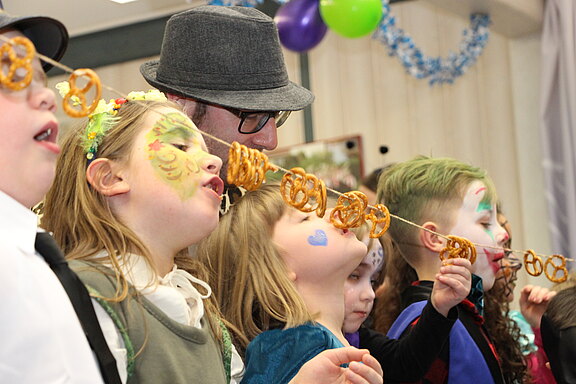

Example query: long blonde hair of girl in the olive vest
[39,101,221,338]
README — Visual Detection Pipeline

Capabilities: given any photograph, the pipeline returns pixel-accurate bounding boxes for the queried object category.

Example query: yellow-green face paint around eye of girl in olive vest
[145,112,208,200]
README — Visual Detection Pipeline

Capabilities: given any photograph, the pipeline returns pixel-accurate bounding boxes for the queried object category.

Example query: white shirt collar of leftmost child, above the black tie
[0,191,38,254]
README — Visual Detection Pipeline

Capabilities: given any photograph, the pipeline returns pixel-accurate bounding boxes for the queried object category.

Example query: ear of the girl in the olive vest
[86,158,130,197]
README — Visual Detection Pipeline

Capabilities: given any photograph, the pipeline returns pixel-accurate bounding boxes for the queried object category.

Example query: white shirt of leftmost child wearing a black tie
[0,191,103,384]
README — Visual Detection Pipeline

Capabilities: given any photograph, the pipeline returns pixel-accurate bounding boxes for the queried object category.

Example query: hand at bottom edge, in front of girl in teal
[289,347,383,384]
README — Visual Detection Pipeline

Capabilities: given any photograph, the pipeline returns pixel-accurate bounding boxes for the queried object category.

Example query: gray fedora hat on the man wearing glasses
[140,5,314,111]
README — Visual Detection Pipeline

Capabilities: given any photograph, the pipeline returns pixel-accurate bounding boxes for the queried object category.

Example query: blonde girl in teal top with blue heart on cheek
[197,185,382,383]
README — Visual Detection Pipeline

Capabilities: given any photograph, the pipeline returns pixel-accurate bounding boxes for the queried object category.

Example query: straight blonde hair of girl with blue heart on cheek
[197,185,313,351]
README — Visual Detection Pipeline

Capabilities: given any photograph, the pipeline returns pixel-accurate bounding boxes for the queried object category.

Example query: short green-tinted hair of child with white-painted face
[377,156,497,264]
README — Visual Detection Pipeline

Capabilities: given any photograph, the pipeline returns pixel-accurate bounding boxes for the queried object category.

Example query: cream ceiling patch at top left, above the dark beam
[0,0,200,36]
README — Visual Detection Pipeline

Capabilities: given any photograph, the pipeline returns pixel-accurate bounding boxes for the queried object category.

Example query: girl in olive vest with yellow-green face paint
[42,100,241,383]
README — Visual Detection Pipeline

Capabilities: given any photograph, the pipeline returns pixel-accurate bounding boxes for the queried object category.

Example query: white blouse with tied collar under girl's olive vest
[92,254,244,384]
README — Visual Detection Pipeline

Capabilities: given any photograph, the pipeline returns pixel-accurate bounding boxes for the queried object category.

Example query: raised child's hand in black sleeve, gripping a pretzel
[431,259,472,316]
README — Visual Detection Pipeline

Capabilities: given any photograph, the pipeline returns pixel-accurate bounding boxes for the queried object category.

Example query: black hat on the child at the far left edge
[0,9,68,71]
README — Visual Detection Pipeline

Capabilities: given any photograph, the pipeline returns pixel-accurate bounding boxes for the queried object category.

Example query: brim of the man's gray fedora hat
[140,60,314,111]
